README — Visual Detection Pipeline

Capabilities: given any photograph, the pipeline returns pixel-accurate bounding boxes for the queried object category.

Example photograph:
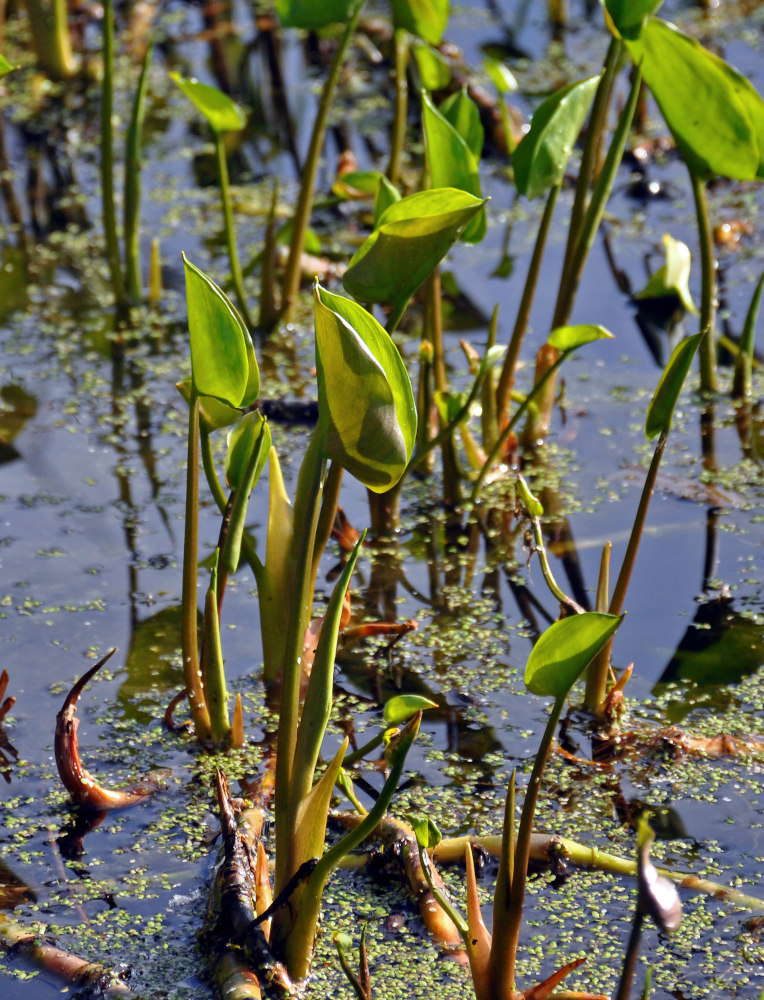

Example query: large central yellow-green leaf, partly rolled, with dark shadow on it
[315,284,416,493]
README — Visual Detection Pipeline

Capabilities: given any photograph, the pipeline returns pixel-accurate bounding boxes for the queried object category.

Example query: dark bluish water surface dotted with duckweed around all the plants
[0,3,764,1000]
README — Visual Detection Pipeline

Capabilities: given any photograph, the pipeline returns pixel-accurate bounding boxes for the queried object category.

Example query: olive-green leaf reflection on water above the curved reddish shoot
[117,604,201,723]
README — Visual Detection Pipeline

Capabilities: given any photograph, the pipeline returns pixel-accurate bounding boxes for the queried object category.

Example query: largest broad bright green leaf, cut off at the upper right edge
[626,18,764,180]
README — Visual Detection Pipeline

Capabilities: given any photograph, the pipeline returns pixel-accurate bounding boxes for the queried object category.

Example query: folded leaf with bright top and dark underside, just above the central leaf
[342,188,484,309]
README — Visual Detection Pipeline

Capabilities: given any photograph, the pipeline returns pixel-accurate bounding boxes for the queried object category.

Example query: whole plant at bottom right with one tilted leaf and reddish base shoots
[411,611,622,1000]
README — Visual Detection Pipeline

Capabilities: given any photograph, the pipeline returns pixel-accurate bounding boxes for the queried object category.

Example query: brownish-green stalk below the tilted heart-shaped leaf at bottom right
[491,695,565,997]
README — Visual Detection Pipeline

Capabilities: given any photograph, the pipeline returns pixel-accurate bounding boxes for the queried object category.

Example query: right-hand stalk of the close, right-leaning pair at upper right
[552,60,642,330]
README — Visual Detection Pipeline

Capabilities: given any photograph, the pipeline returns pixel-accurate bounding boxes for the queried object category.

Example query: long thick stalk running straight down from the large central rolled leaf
[274,432,326,894]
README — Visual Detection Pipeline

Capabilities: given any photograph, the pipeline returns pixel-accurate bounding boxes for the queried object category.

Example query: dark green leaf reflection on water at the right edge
[658,595,764,687]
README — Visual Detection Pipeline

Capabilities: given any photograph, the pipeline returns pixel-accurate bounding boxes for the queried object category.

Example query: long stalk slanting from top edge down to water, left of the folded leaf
[281,0,363,319]
